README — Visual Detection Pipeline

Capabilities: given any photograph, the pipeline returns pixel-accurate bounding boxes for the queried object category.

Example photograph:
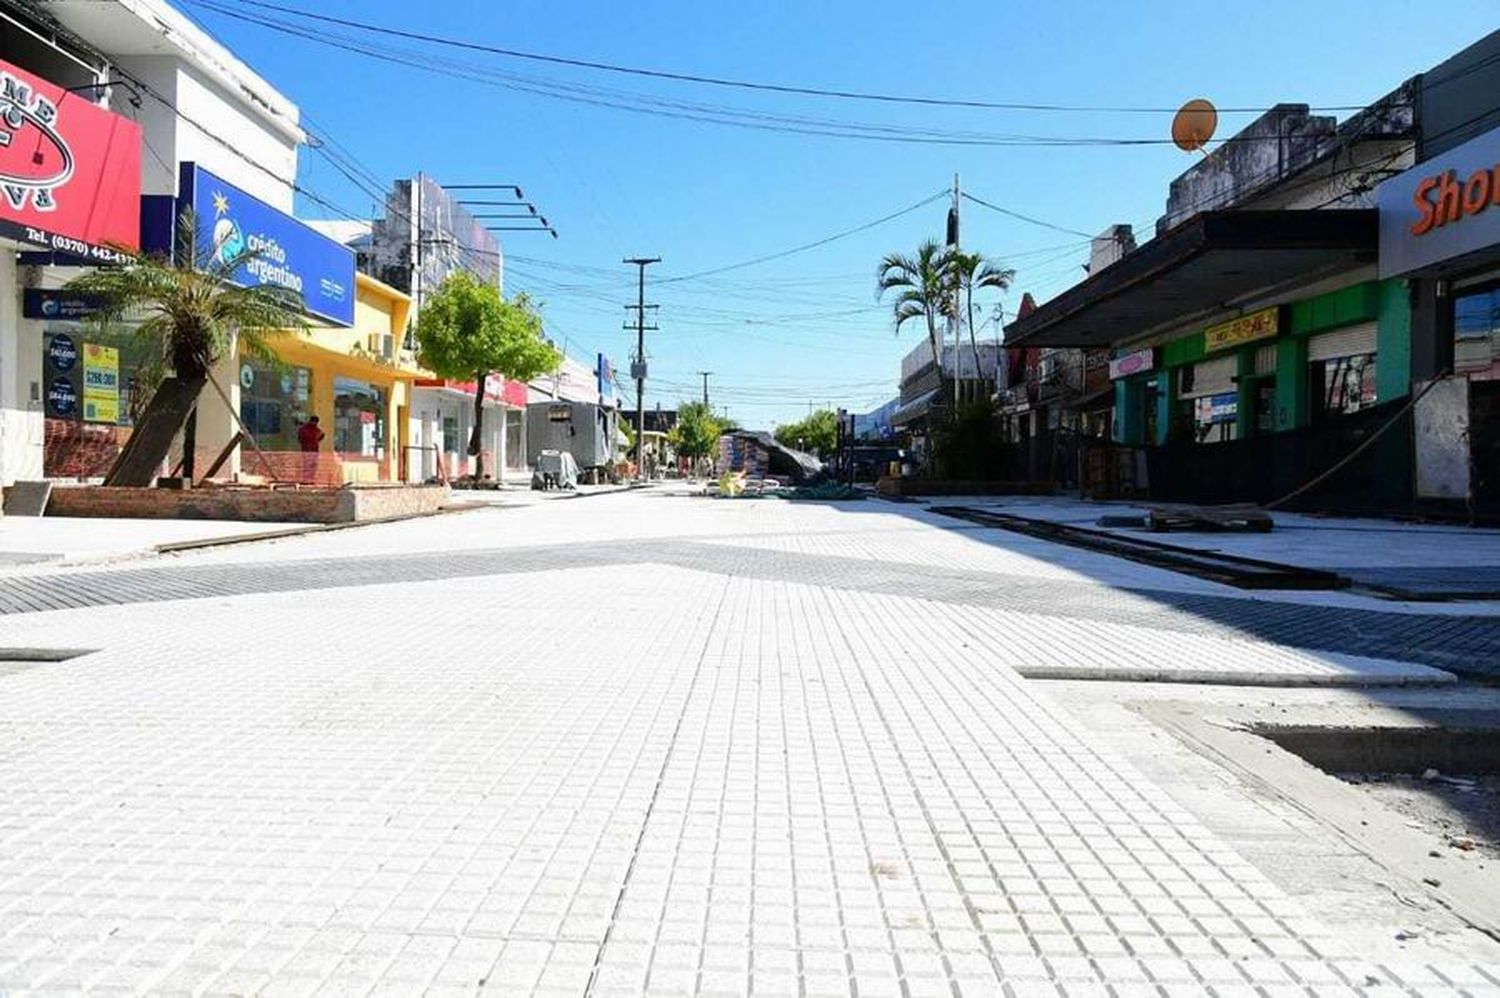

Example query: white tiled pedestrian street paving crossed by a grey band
[0,488,1500,998]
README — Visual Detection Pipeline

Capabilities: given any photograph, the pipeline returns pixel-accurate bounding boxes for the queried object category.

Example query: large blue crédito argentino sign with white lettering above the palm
[179,164,354,326]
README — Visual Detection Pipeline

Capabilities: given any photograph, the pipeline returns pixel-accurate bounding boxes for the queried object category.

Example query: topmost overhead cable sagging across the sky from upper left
[189,0,1364,114]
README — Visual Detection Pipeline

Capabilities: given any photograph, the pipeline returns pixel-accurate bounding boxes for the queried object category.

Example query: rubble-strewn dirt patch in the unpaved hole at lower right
[1334,773,1500,869]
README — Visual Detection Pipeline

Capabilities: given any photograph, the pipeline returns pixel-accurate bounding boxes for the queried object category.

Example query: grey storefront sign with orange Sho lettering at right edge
[1376,122,1500,278]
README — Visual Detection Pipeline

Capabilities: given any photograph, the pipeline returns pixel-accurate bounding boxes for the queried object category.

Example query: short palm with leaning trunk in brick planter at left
[66,210,308,485]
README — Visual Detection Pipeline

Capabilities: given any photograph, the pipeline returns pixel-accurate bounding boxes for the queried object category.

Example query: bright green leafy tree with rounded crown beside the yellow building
[417,270,563,477]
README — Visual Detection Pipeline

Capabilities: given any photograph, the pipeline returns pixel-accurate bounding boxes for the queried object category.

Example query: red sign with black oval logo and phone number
[0,60,141,260]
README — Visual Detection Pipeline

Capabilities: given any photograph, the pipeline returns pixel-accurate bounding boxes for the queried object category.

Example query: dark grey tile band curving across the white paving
[0,531,1500,675]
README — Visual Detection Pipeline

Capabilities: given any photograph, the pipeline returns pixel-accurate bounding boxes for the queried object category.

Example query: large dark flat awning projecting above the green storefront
[1005,209,1379,347]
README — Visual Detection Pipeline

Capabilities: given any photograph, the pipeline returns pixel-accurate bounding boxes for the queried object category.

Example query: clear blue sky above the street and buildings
[187,0,1500,426]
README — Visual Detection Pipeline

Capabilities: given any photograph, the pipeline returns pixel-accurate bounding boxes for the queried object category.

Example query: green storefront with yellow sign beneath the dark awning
[1113,281,1412,446]
